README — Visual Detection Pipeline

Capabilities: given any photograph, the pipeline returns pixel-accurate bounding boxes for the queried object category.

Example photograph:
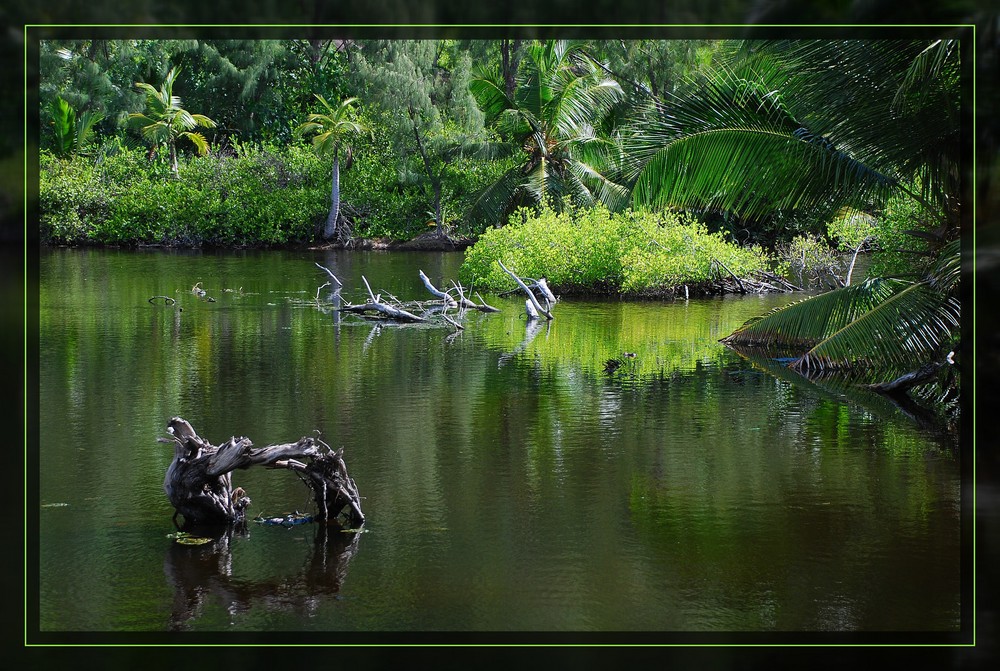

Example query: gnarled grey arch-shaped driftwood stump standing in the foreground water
[159,417,365,526]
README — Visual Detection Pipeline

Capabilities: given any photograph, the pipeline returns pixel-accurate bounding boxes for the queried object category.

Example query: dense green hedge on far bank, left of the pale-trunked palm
[41,146,327,247]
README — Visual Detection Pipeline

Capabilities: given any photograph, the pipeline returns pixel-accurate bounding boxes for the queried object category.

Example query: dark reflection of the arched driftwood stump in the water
[163,523,361,631]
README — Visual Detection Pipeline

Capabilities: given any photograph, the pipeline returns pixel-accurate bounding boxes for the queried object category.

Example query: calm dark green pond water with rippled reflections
[37,249,962,641]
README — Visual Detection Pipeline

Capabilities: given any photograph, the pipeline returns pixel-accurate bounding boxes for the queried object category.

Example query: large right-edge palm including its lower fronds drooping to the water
[632,40,961,380]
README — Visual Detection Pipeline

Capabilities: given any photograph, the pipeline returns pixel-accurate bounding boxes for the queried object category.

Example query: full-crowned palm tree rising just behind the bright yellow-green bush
[469,40,628,224]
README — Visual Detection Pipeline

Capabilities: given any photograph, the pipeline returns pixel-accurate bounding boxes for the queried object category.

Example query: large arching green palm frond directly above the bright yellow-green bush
[630,60,908,217]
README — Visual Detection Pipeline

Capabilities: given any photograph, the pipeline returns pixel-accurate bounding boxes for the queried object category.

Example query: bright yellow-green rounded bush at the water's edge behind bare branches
[462,206,768,293]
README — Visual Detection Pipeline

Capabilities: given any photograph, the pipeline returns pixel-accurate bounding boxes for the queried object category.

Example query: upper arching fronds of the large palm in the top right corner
[628,40,961,234]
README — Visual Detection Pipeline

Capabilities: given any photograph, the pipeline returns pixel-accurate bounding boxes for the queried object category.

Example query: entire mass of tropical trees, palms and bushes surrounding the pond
[39,39,964,400]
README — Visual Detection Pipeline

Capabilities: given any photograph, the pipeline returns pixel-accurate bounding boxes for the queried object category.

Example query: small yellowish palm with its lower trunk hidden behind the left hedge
[129,67,215,177]
